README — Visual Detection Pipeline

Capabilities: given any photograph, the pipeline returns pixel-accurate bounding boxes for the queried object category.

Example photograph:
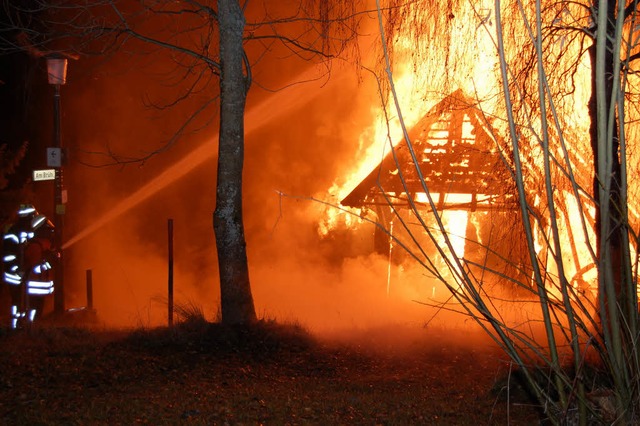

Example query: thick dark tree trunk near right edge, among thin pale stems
[589,0,637,412]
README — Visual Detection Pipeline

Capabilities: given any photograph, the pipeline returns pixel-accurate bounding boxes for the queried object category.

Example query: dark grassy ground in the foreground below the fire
[0,321,538,425]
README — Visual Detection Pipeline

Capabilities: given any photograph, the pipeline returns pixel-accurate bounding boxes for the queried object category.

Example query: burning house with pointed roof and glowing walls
[341,90,527,292]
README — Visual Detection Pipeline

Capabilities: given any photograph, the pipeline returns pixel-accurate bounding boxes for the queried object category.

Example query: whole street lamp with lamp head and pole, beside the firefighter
[46,53,67,315]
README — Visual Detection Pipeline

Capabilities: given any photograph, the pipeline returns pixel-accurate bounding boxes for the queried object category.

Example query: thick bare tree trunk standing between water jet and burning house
[213,0,256,324]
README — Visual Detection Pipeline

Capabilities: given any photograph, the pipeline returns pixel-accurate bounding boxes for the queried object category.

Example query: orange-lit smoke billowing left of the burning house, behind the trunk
[48,1,490,333]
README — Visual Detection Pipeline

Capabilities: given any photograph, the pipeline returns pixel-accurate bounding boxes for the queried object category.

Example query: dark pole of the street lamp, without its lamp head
[53,84,65,315]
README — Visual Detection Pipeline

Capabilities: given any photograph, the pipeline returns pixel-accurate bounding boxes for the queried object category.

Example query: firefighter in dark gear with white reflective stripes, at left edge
[3,204,55,328]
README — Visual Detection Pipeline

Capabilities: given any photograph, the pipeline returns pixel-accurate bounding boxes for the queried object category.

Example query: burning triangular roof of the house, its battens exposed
[341,90,515,211]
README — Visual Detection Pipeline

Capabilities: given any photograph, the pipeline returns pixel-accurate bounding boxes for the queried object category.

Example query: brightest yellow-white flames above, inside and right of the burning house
[319,2,594,306]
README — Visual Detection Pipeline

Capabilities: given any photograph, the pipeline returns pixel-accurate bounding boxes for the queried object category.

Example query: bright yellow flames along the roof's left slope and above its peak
[319,0,498,230]
